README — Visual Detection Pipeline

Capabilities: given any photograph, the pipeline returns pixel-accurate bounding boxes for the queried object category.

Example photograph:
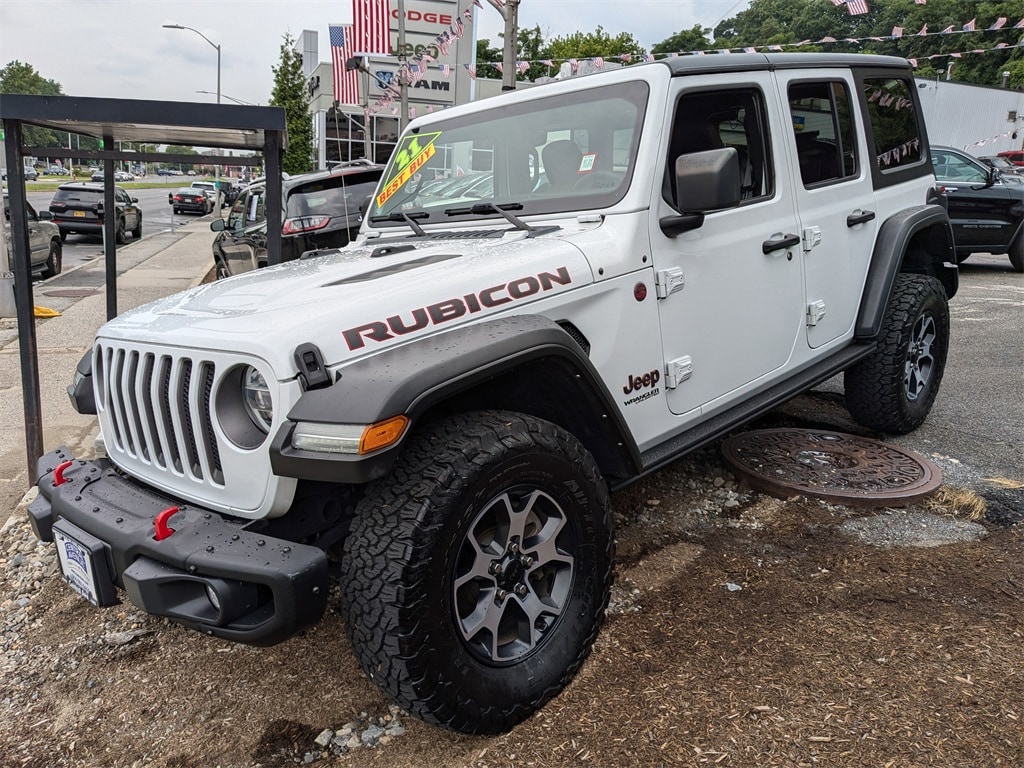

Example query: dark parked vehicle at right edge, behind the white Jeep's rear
[932,146,1024,272]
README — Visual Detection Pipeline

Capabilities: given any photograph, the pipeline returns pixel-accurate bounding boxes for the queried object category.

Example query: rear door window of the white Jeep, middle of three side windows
[790,82,857,186]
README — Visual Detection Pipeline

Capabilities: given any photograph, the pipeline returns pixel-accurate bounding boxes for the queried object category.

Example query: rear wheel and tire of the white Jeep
[844,274,949,434]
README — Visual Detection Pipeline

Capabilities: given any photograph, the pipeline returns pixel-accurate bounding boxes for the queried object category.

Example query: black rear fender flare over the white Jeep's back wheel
[854,204,959,340]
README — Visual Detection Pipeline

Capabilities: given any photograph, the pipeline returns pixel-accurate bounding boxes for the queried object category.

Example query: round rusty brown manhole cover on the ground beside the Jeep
[722,429,942,507]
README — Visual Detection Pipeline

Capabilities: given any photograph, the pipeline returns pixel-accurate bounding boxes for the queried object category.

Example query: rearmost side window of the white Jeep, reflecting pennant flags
[864,78,925,174]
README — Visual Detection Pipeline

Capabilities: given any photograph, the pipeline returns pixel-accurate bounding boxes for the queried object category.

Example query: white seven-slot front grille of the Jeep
[93,344,224,485]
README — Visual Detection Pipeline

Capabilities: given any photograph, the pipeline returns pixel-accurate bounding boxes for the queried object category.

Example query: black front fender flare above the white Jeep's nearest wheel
[270,314,641,483]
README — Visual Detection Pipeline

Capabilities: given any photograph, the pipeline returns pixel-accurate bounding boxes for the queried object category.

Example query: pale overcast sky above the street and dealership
[0,0,749,110]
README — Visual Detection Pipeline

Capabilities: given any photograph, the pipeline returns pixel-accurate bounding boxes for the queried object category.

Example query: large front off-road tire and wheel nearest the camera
[341,411,612,733]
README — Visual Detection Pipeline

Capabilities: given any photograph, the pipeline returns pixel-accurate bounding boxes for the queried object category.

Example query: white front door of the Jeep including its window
[651,73,803,414]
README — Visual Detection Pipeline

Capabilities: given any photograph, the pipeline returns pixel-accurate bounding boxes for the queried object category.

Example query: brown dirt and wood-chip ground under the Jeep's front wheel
[0,438,1024,768]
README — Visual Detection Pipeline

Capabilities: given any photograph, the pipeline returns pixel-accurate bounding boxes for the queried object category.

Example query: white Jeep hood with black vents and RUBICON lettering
[98,231,593,379]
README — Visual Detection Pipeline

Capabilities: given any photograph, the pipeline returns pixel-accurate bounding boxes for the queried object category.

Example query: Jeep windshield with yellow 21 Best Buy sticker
[369,81,648,226]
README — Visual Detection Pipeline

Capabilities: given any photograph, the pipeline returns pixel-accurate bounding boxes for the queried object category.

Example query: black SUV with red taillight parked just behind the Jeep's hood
[210,161,384,278]
